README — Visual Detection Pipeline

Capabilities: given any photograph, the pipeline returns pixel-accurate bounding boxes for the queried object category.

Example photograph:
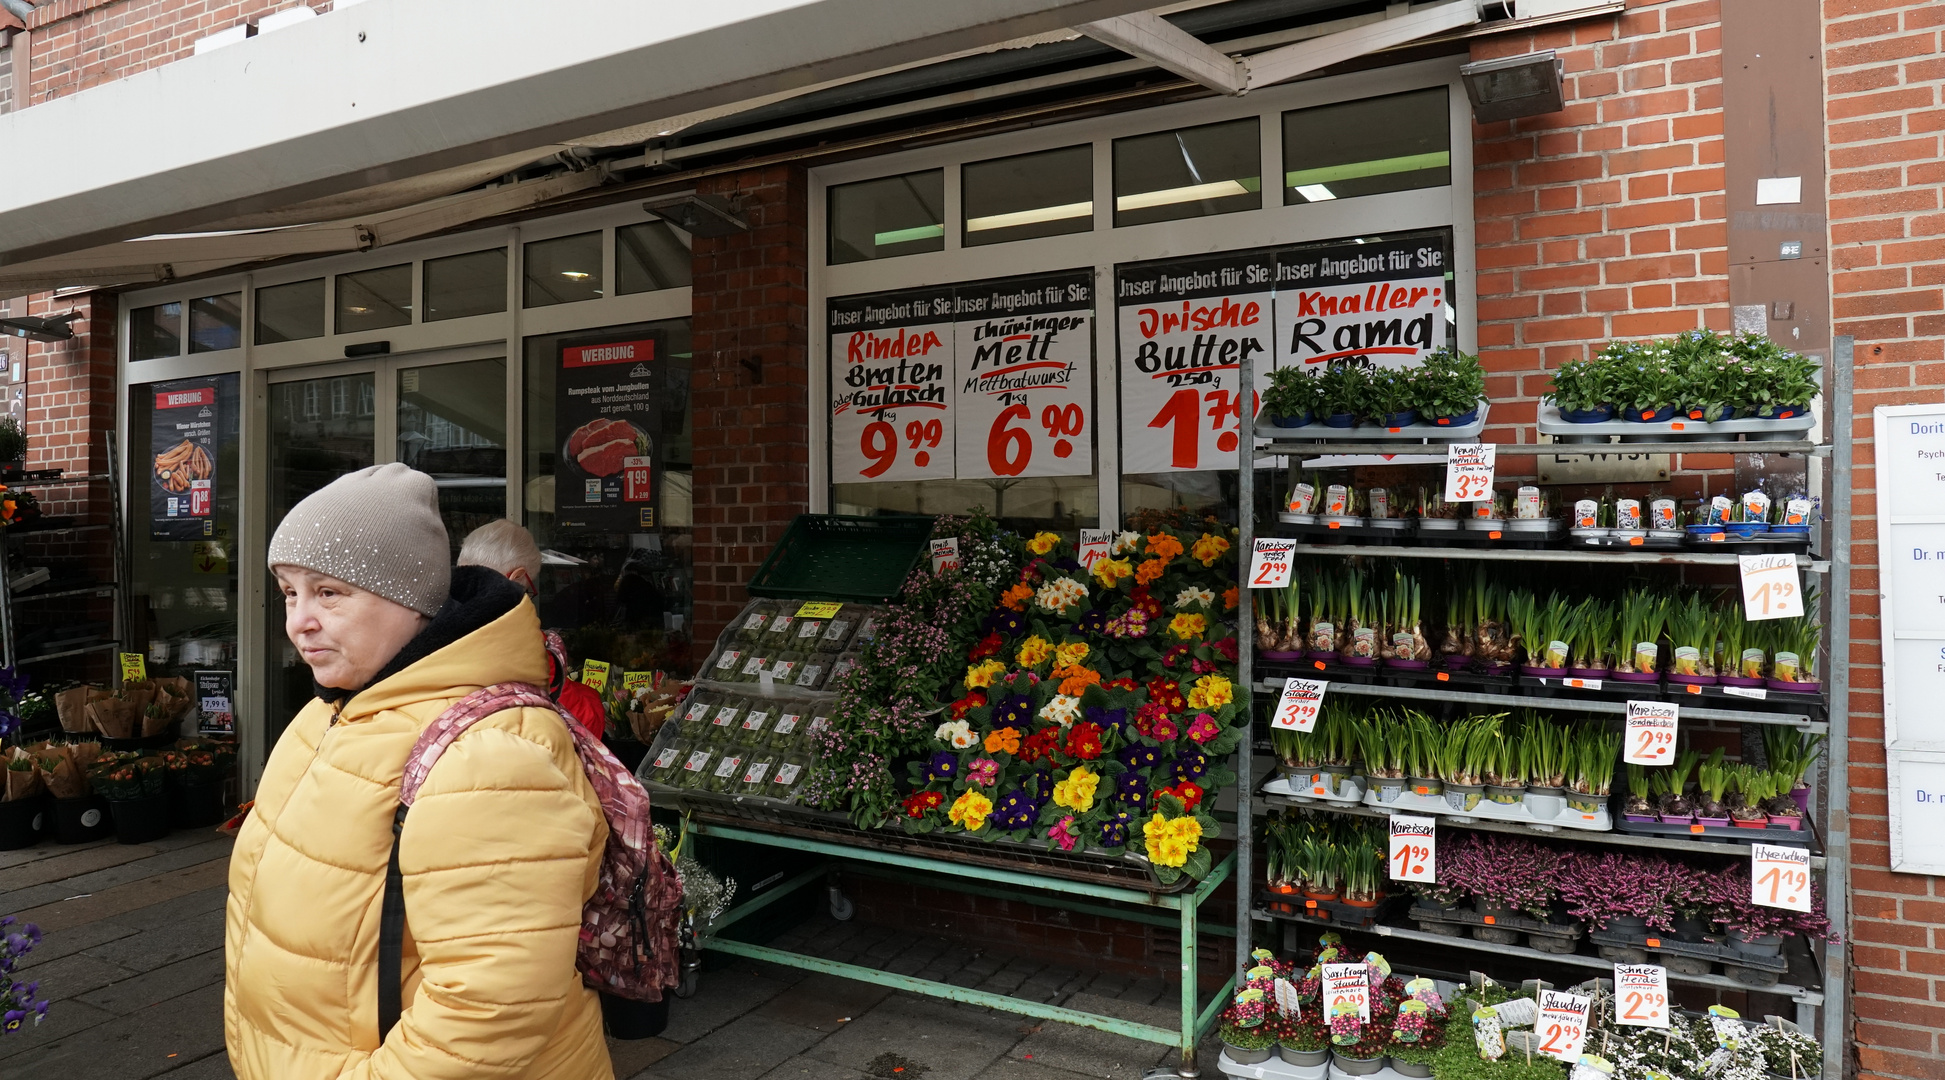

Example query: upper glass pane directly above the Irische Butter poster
[1114,117,1262,228]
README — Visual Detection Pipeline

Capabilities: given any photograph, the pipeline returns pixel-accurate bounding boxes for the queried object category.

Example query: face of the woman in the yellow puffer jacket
[272,566,426,691]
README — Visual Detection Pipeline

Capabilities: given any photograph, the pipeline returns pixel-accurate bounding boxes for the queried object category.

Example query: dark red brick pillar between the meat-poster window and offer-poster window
[690,165,811,660]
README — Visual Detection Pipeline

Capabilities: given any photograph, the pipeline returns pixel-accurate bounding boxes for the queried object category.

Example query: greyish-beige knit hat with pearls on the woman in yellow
[270,461,453,615]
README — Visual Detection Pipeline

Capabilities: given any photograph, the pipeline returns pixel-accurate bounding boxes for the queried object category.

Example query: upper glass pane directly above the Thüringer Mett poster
[961,146,1093,247]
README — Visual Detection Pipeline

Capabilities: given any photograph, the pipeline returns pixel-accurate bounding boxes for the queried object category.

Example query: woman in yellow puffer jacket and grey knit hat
[224,465,613,1080]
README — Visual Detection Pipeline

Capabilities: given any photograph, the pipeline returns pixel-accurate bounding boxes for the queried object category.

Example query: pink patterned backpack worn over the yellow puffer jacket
[377,683,683,1041]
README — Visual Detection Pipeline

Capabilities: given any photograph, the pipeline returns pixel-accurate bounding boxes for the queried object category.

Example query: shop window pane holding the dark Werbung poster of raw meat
[521,319,706,675]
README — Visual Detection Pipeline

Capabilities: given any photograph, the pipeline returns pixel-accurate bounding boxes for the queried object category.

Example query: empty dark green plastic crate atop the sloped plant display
[749,514,932,603]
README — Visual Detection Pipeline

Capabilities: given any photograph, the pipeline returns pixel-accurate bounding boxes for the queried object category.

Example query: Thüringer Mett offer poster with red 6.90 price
[953,270,1093,481]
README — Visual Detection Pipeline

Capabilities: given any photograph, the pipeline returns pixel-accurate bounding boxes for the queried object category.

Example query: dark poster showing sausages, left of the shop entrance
[148,376,220,541]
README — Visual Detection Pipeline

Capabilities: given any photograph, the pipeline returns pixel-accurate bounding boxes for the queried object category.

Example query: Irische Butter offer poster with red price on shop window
[1114,253,1276,473]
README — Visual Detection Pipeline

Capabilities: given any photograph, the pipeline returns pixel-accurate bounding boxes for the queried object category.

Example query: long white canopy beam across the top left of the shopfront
[0,0,1144,265]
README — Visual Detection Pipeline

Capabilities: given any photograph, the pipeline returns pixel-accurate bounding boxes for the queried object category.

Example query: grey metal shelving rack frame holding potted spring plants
[1235,337,1854,1080]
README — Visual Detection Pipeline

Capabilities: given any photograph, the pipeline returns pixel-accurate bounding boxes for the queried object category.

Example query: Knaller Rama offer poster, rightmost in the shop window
[1276,235,1449,368]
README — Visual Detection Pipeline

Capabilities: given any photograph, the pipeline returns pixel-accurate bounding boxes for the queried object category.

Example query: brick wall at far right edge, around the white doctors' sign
[1822,0,1945,1080]
